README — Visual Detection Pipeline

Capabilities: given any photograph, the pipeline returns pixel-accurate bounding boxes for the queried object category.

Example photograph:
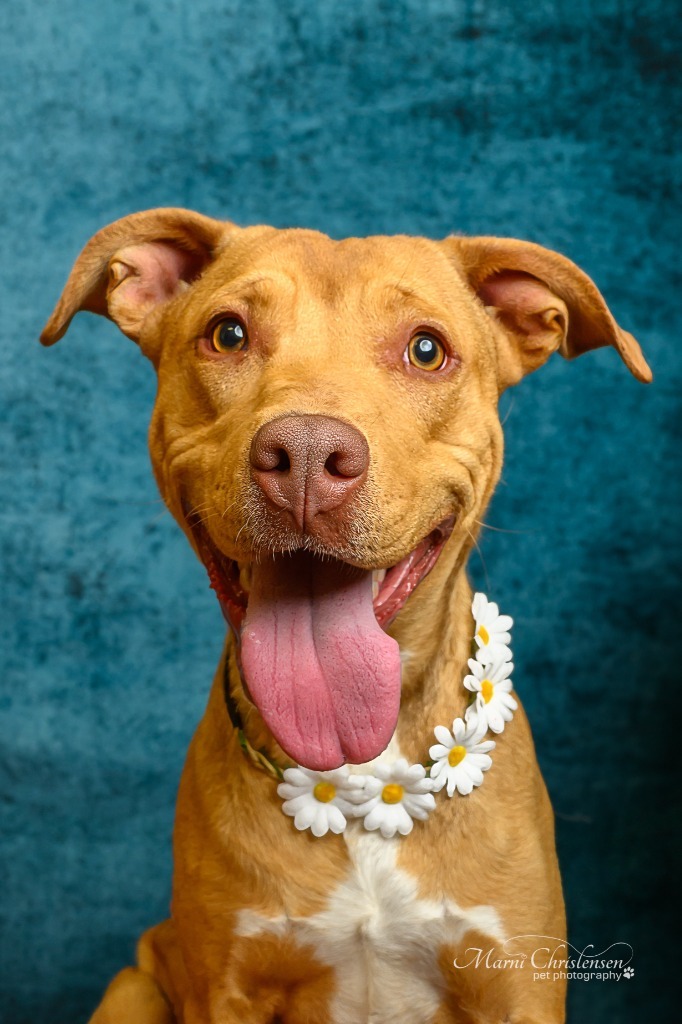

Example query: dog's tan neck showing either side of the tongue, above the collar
[224,545,473,768]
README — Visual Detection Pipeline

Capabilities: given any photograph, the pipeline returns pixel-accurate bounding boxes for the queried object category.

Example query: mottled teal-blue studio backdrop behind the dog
[0,0,682,1024]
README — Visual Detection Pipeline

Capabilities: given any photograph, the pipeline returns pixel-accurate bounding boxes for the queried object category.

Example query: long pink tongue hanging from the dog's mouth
[242,553,400,771]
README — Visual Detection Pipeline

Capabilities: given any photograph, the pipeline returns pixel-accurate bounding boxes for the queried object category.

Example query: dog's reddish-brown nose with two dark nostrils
[251,416,370,531]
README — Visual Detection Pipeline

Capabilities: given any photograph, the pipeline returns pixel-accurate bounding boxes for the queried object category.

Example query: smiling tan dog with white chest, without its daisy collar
[42,209,651,1024]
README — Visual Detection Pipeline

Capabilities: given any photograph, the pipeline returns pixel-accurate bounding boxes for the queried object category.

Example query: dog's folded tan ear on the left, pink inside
[40,208,229,345]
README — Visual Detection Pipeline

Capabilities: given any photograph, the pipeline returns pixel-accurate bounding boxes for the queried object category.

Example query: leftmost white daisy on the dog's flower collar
[278,765,367,837]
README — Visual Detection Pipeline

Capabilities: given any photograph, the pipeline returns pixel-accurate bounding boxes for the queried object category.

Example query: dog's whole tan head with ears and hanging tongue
[41,209,651,769]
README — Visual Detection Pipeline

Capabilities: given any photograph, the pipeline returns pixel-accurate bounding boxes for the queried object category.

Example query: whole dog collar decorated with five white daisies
[236,594,518,839]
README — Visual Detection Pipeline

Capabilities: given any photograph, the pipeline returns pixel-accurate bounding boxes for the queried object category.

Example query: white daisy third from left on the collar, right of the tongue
[429,706,495,797]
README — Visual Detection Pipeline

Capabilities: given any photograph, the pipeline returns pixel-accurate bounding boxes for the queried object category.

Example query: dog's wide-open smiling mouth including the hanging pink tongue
[188,518,454,771]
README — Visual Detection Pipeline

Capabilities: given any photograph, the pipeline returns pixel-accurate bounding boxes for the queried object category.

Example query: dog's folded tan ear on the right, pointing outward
[441,236,652,389]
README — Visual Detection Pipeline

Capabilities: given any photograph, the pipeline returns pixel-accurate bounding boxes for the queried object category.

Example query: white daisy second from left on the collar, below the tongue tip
[355,758,435,839]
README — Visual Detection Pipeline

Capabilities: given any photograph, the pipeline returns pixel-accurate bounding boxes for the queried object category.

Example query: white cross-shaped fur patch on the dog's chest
[233,822,501,1024]
